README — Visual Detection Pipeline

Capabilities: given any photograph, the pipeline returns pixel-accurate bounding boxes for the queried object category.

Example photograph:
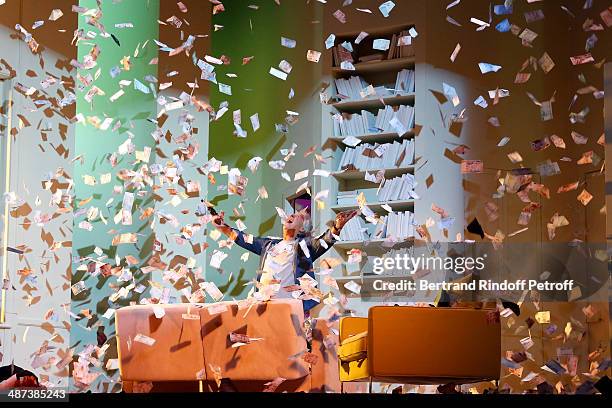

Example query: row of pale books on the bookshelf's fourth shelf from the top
[338,139,414,171]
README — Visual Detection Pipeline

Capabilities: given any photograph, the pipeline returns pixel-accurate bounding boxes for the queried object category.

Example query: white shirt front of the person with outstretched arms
[261,240,295,299]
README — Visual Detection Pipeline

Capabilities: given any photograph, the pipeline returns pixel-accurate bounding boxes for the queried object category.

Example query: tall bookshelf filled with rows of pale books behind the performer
[315,23,419,294]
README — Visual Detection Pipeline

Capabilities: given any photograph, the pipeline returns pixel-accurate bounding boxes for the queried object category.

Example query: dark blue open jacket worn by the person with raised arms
[232,228,336,311]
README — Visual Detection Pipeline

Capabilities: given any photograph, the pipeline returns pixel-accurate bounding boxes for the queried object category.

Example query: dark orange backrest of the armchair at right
[367,306,501,384]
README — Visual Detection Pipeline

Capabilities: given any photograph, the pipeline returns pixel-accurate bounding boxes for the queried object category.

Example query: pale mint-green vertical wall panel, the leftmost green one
[70,0,159,391]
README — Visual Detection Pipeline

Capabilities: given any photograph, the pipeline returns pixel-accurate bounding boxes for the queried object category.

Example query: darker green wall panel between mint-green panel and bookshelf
[207,0,323,298]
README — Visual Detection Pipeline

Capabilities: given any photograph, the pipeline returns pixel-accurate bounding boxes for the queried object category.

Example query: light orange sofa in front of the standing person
[115,299,339,392]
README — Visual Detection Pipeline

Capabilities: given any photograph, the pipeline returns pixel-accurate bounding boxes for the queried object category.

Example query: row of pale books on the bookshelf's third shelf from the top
[333,105,414,136]
